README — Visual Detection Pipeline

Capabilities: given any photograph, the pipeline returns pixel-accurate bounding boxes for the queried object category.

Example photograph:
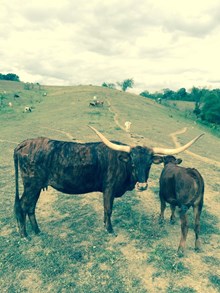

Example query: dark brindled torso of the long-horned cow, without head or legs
[14,137,134,196]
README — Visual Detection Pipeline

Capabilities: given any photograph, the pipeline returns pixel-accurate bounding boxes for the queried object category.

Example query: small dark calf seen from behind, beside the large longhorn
[159,156,204,253]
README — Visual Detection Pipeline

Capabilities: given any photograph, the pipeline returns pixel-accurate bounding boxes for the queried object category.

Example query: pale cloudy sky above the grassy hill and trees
[0,0,220,93]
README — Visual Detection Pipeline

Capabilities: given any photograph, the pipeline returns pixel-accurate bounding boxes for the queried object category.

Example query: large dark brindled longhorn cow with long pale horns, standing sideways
[14,126,201,237]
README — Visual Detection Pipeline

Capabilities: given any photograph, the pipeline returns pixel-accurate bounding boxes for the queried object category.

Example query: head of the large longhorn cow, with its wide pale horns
[89,126,203,191]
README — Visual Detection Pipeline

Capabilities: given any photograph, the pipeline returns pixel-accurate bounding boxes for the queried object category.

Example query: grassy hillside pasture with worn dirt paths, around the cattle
[0,82,220,293]
